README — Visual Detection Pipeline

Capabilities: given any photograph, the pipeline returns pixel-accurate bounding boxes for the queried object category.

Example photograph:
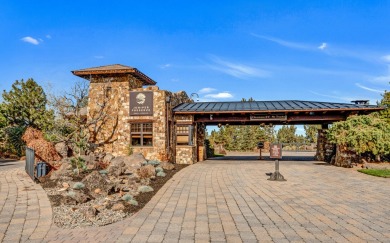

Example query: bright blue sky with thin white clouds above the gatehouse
[0,0,390,104]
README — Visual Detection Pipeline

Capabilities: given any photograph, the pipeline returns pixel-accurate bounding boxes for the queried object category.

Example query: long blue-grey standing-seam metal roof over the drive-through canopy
[173,100,382,113]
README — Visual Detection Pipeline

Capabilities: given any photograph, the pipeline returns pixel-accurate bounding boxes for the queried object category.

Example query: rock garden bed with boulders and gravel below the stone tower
[40,154,186,228]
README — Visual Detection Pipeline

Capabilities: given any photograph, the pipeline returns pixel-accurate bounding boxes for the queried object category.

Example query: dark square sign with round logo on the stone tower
[130,91,153,116]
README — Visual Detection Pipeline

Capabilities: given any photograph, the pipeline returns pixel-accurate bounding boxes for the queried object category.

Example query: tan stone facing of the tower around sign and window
[88,76,193,161]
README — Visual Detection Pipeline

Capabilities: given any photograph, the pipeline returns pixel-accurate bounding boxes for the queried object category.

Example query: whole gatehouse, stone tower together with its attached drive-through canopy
[72,64,382,164]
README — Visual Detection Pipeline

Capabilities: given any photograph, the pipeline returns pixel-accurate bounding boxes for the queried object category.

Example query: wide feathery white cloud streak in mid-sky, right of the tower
[208,56,270,79]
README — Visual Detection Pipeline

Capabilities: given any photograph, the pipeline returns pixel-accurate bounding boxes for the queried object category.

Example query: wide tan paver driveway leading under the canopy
[0,153,390,242]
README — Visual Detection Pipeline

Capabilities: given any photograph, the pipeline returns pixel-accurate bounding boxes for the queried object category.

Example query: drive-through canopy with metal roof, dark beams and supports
[173,100,383,162]
